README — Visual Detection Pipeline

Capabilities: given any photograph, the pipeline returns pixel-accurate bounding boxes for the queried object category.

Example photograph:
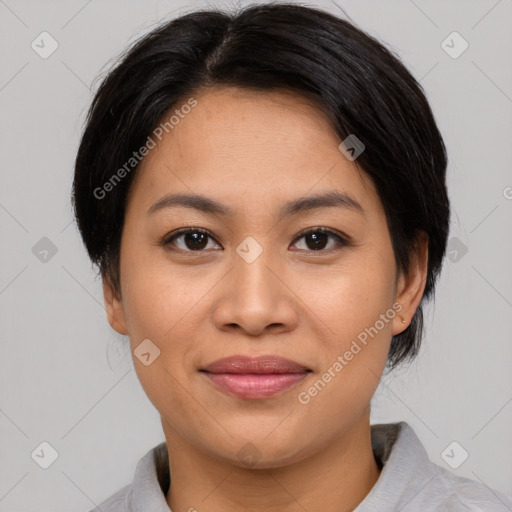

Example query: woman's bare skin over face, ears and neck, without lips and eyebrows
[104,87,427,512]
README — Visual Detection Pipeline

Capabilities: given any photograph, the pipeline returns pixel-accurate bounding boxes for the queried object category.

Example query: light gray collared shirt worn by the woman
[91,422,512,512]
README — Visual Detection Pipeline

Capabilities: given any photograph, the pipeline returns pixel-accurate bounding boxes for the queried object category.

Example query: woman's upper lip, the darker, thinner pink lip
[201,356,311,374]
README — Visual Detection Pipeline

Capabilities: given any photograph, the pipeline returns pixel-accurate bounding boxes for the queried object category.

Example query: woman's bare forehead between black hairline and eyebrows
[126,87,375,216]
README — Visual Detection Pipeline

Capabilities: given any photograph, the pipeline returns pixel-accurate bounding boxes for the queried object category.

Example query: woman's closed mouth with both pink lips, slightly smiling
[200,356,312,400]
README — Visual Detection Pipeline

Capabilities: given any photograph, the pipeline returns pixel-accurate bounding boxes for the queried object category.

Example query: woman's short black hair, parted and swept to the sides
[72,3,450,368]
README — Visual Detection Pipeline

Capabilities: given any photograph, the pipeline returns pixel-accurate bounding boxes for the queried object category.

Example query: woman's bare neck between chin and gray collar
[163,411,380,512]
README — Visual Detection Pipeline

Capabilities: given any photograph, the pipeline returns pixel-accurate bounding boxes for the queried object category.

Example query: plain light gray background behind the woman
[0,0,512,512]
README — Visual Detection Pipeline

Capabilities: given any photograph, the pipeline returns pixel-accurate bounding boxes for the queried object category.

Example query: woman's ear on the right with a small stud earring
[393,231,428,336]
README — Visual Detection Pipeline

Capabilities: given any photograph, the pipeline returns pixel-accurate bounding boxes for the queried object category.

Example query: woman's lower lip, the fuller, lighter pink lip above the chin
[204,372,308,399]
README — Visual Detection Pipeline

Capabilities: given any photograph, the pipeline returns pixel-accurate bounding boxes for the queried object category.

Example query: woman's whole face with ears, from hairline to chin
[105,88,423,467]
